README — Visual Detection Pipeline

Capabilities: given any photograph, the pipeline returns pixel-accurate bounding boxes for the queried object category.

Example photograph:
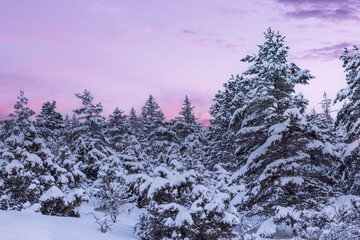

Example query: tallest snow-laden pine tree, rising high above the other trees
[228,29,341,236]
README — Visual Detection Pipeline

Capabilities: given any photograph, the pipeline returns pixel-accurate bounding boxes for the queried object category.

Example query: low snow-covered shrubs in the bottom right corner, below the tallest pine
[243,195,360,240]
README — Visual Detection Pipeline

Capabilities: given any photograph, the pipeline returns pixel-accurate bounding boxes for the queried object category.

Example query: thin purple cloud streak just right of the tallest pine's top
[295,42,353,61]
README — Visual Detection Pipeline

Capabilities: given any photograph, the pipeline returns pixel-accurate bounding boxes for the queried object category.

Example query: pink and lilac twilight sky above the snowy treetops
[0,0,360,119]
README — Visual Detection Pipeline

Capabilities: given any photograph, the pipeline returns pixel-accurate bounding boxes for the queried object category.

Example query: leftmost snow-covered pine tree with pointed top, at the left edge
[1,91,55,210]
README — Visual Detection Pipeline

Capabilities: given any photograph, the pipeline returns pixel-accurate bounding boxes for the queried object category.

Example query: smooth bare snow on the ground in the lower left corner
[0,210,138,240]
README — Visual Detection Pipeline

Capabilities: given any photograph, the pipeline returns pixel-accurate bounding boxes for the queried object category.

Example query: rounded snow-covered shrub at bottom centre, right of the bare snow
[136,162,239,240]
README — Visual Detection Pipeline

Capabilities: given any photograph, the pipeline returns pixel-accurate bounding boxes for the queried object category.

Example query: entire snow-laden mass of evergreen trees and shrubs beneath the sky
[0,28,360,240]
